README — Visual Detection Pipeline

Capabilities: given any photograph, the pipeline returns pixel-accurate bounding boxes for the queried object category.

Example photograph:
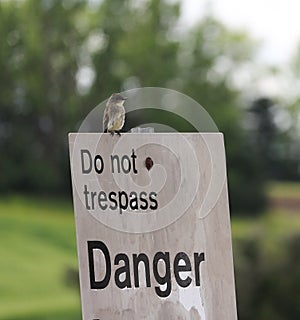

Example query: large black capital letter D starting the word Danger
[87,241,111,289]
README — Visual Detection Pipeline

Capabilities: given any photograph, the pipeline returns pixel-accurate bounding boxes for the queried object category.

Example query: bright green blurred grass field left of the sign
[0,197,80,320]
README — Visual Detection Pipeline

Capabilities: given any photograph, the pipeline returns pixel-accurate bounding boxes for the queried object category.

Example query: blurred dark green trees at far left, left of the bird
[0,0,84,193]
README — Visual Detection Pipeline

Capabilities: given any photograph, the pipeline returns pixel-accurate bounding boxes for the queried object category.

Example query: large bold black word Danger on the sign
[87,241,204,298]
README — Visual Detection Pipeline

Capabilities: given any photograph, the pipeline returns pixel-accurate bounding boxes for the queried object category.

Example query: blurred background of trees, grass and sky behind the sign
[0,0,300,320]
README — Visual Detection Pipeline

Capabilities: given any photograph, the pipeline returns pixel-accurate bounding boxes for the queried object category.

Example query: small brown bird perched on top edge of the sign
[103,93,127,136]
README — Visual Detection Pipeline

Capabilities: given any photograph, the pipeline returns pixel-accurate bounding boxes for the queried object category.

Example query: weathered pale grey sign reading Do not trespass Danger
[69,133,237,320]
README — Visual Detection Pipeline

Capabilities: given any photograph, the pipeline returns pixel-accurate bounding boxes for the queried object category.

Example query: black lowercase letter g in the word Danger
[153,252,172,298]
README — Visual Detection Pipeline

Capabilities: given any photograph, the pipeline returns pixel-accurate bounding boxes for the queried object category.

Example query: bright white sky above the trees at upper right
[181,0,300,65]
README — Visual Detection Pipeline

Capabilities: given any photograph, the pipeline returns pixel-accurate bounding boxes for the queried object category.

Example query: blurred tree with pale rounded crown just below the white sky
[175,16,265,214]
